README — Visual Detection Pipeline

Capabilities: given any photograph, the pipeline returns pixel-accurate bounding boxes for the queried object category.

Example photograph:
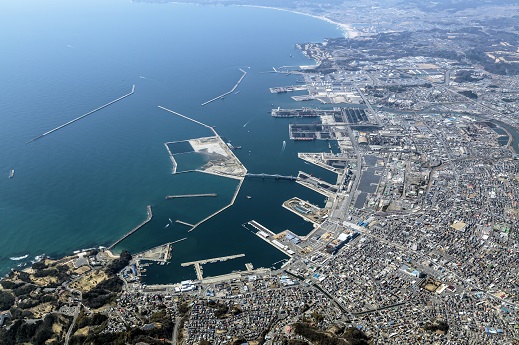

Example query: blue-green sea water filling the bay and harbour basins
[0,0,343,284]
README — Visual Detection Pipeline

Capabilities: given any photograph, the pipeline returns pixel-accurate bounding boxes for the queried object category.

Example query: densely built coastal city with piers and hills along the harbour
[0,0,519,345]
